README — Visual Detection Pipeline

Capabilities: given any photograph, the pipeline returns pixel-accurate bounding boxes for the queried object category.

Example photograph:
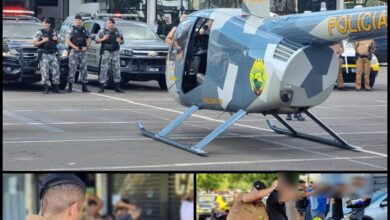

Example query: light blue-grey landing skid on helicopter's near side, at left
[137,105,246,156]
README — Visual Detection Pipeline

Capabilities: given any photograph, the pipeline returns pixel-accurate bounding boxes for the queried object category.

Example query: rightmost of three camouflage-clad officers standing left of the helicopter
[96,18,124,93]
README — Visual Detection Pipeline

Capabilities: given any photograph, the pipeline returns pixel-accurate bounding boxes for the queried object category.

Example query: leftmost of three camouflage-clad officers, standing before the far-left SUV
[33,18,62,94]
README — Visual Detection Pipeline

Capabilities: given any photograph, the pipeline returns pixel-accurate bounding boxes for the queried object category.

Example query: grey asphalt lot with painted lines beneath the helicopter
[3,66,388,171]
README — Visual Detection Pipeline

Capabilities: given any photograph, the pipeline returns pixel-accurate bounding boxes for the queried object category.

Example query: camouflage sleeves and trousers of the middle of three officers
[66,27,90,83]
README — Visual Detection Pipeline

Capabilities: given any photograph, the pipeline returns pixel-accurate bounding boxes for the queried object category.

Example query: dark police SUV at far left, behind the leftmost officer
[3,14,69,89]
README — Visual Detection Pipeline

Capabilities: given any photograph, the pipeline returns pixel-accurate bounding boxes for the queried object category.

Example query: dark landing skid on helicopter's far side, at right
[266,109,361,151]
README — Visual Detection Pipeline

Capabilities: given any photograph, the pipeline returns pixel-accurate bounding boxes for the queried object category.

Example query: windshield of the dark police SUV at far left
[3,23,41,39]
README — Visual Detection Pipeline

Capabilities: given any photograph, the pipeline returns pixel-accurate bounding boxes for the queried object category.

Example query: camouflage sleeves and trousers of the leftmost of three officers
[34,30,60,85]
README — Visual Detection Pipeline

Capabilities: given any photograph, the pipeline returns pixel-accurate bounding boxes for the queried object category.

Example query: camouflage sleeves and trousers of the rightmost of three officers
[98,28,123,83]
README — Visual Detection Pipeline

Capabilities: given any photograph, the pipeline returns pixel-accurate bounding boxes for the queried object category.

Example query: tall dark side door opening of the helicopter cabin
[183,18,213,92]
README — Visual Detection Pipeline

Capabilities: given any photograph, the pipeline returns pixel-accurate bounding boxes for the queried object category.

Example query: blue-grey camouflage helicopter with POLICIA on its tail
[137,0,387,156]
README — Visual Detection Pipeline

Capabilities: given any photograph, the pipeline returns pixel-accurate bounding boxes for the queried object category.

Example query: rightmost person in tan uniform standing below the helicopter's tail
[355,40,375,91]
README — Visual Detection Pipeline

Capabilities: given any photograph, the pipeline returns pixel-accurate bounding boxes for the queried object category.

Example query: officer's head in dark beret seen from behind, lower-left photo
[27,173,85,220]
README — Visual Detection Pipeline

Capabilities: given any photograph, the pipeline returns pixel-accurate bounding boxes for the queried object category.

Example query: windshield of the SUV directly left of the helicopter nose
[118,25,158,40]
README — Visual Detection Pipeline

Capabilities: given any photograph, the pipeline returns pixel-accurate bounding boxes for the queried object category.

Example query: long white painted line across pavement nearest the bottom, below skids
[39,156,387,171]
